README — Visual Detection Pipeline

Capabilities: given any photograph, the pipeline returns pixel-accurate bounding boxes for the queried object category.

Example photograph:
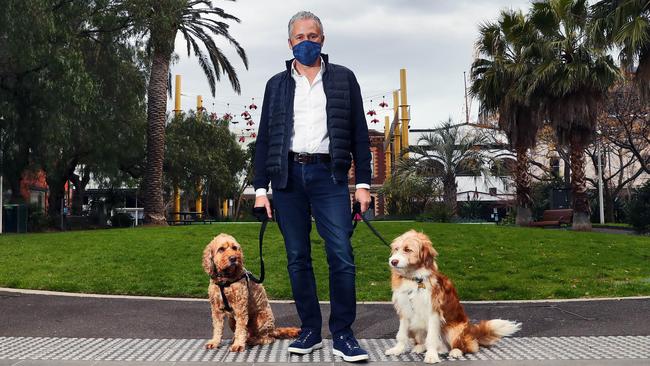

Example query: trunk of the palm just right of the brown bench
[570,136,591,231]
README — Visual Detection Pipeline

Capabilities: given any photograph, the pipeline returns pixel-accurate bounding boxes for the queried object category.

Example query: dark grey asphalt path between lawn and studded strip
[0,291,650,339]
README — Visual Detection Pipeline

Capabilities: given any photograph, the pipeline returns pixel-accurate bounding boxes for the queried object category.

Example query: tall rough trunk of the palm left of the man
[144,50,170,225]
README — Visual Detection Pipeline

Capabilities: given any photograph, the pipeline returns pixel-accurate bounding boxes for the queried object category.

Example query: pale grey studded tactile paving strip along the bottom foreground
[0,336,650,363]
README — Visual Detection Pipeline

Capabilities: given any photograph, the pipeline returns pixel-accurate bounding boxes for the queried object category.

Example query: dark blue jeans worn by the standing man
[273,162,356,336]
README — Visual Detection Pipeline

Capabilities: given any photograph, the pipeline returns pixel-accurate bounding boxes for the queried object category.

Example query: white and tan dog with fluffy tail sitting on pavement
[386,230,521,363]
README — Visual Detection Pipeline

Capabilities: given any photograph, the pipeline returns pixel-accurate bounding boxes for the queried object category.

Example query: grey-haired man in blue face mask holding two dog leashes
[253,12,370,362]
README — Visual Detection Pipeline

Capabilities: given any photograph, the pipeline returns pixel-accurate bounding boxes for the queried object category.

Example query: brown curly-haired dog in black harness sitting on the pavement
[203,233,300,352]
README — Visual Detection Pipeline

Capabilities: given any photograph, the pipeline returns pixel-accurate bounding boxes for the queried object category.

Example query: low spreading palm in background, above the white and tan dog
[396,119,489,215]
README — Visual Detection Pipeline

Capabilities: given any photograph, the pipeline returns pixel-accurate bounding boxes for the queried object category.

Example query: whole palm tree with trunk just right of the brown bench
[529,0,620,230]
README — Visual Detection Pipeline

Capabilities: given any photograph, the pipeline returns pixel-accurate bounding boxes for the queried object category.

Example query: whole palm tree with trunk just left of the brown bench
[471,10,543,225]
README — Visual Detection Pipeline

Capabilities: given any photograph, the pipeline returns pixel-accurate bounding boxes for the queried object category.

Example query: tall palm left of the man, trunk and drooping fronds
[128,0,248,225]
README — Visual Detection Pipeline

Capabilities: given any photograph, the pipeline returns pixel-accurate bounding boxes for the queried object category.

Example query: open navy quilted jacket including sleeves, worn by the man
[253,54,370,189]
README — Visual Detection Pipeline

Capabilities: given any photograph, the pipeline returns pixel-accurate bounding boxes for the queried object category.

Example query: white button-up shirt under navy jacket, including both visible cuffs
[255,59,370,197]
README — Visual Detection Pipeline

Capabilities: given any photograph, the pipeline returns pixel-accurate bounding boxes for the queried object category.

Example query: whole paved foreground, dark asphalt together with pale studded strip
[0,289,650,366]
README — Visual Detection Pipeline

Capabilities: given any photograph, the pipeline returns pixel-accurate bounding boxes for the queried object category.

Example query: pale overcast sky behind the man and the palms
[168,0,530,131]
